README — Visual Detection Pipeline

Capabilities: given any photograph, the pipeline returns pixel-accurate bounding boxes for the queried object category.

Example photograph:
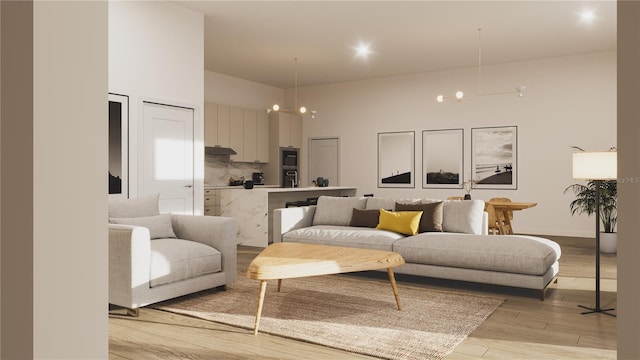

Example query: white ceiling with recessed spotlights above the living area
[179,0,616,88]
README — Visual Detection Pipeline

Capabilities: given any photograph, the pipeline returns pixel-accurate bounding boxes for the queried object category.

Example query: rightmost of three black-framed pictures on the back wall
[471,126,518,189]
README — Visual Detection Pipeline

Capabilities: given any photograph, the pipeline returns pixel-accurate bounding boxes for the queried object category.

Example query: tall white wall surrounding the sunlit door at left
[109,1,204,214]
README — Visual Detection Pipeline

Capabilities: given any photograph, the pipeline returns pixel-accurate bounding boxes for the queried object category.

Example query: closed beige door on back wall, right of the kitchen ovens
[309,138,340,186]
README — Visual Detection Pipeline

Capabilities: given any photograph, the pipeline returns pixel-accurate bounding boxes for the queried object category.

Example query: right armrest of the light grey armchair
[171,214,238,282]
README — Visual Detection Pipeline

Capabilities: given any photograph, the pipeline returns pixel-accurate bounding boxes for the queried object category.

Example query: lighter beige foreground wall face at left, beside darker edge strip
[34,1,109,359]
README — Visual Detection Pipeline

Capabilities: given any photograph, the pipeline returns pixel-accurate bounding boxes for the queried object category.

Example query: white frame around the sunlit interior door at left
[137,96,204,215]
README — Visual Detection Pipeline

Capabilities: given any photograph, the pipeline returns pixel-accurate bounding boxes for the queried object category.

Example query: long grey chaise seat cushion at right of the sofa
[393,233,561,275]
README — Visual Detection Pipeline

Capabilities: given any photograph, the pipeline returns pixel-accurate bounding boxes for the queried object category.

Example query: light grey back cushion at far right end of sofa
[442,200,484,234]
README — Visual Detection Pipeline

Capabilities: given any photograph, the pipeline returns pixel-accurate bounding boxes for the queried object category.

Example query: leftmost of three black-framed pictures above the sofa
[378,131,415,188]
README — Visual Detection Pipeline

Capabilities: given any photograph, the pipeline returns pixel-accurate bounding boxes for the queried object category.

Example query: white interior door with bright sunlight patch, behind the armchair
[140,102,194,215]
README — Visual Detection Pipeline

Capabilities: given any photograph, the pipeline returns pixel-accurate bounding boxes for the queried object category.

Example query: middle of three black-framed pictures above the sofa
[422,129,464,188]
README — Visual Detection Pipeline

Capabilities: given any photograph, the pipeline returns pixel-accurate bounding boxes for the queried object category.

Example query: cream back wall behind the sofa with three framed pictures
[299,51,616,237]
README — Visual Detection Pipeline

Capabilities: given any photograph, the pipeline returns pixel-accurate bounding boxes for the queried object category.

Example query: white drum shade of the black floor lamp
[573,151,618,180]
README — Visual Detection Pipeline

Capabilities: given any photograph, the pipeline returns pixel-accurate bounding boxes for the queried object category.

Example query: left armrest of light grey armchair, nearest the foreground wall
[109,224,151,308]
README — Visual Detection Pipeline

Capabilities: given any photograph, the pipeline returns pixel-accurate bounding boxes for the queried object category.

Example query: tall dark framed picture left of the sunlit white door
[109,93,129,199]
